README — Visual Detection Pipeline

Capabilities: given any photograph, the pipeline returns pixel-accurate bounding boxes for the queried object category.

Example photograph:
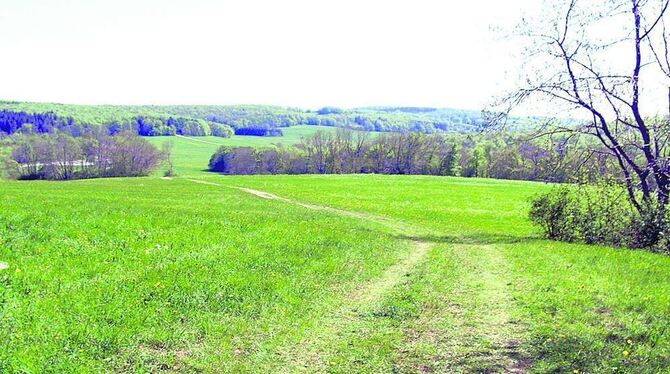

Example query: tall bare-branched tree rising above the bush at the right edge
[503,0,670,210]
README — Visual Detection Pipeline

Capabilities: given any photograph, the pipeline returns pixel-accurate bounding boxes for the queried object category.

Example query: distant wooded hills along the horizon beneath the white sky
[0,101,533,137]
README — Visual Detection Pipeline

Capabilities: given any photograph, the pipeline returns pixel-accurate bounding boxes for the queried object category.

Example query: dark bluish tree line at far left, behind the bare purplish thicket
[0,110,233,137]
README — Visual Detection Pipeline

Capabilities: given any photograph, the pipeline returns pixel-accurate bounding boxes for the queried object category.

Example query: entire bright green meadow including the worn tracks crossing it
[0,138,670,373]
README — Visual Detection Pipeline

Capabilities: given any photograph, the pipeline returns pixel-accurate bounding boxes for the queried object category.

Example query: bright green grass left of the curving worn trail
[0,179,407,372]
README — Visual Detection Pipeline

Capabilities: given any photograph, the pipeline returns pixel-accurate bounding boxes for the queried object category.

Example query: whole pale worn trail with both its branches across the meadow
[182,179,529,373]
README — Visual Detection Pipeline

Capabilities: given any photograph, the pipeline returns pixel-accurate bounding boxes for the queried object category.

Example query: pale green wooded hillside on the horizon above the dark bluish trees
[0,101,531,135]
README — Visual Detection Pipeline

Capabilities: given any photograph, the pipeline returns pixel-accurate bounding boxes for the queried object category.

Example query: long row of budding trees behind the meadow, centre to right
[210,129,616,182]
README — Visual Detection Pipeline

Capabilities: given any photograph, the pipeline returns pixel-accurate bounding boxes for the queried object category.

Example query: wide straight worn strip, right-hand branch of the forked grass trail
[426,244,528,373]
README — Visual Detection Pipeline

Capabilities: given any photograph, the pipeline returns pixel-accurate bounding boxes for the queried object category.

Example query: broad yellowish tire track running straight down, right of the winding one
[400,243,530,373]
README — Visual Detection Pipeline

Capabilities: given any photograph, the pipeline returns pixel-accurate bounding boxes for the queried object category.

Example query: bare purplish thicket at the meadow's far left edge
[4,132,167,180]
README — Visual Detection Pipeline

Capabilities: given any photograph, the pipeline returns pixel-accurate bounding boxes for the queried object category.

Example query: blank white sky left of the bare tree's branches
[0,0,537,109]
